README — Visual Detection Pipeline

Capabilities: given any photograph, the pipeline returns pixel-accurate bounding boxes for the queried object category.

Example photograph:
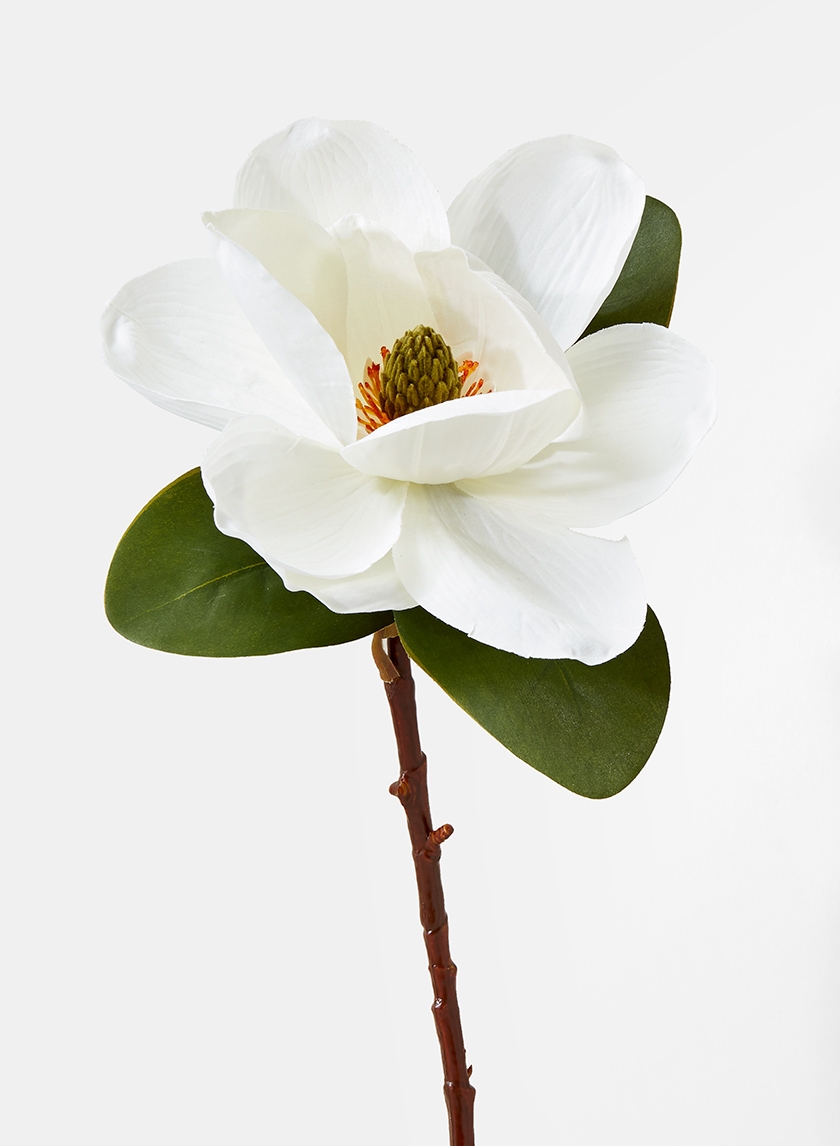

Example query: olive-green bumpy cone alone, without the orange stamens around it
[380,327,461,419]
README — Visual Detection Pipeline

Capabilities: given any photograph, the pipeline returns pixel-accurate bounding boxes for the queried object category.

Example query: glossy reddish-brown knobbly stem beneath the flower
[374,626,476,1146]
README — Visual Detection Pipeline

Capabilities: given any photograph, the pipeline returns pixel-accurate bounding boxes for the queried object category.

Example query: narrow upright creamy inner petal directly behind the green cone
[332,217,432,383]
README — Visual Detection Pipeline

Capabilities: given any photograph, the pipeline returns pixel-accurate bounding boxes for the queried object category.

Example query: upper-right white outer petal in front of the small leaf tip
[449,135,644,348]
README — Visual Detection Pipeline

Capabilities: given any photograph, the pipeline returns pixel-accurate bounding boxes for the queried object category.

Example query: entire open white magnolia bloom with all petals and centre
[103,119,714,664]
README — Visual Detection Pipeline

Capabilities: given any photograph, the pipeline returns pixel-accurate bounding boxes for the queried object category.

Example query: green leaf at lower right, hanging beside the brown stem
[394,609,670,800]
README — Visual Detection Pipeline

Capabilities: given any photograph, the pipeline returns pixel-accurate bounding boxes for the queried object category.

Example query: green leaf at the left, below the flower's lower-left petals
[105,470,392,657]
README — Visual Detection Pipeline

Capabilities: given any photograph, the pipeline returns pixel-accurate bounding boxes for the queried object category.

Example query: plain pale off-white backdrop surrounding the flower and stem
[0,0,840,1146]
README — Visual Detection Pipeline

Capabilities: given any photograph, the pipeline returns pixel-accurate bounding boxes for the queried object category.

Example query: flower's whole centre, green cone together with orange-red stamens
[356,327,493,433]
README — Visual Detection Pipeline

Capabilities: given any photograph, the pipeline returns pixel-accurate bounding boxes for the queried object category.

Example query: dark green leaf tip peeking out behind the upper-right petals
[581,195,682,338]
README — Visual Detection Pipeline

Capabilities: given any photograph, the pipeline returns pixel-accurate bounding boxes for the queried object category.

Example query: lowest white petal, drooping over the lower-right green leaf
[394,486,646,665]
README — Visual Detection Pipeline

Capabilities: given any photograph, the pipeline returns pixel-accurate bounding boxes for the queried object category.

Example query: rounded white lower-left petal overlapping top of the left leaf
[202,418,406,576]
